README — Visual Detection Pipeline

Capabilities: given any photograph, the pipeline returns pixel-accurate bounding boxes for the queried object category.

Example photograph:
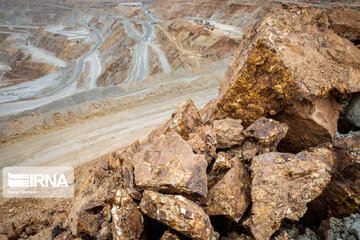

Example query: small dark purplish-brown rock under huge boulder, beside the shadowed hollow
[244,117,289,151]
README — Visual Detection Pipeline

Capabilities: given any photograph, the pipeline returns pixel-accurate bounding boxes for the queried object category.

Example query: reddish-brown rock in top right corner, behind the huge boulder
[329,7,360,47]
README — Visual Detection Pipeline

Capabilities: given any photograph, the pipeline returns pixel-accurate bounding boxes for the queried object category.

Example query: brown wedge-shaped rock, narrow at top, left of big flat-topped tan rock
[204,159,251,222]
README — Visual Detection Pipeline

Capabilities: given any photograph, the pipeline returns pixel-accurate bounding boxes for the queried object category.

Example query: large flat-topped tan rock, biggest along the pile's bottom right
[246,147,333,240]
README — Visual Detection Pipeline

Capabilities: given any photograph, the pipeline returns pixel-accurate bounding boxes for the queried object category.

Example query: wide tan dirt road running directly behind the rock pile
[0,88,217,168]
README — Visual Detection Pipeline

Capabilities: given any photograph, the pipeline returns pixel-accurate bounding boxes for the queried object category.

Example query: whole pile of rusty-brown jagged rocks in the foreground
[51,4,360,240]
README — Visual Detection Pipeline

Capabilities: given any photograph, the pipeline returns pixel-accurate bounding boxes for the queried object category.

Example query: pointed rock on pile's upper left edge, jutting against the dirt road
[165,99,202,140]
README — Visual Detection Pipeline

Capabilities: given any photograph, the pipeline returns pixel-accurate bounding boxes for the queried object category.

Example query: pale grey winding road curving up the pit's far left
[0,11,103,116]
